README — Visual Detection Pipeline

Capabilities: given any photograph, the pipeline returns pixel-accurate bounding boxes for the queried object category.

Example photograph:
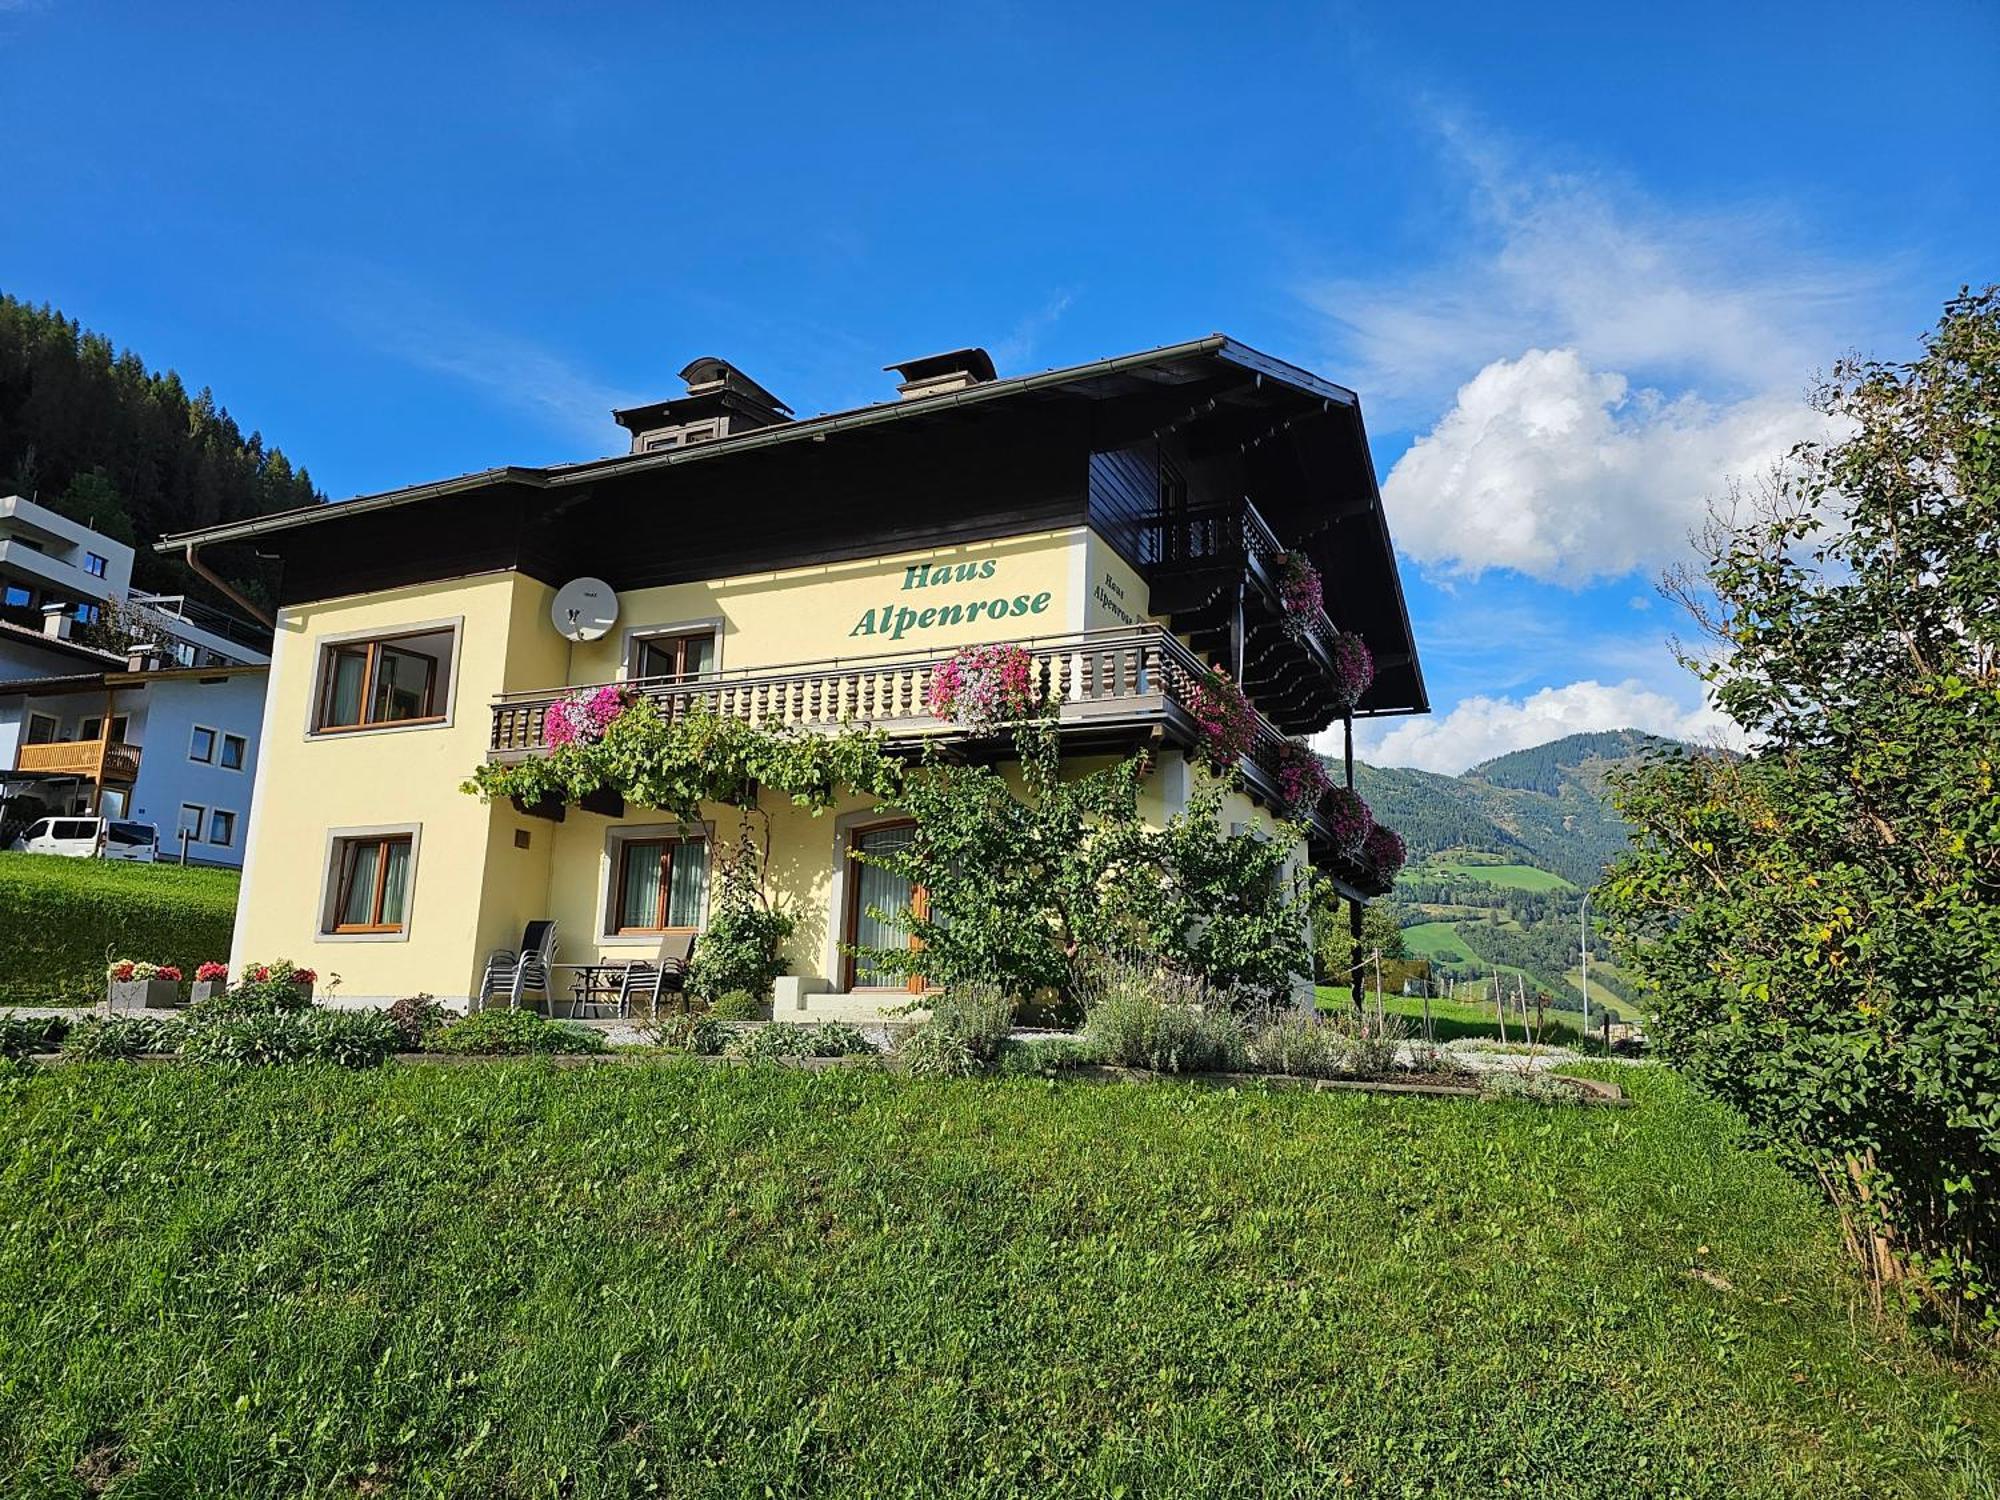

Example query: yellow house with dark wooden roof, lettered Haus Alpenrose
[160,336,1428,1014]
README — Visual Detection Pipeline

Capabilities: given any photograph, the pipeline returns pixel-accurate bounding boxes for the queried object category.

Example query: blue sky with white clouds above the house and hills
[0,0,2000,770]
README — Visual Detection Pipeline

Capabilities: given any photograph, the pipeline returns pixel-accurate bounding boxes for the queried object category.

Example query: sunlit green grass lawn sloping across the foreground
[0,1064,2000,1498]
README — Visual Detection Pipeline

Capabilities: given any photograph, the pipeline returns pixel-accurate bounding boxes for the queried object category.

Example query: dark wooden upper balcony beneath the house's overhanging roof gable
[1138,496,1376,734]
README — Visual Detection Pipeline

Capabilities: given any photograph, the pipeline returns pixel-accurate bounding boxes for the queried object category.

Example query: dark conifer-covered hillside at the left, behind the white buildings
[0,294,324,594]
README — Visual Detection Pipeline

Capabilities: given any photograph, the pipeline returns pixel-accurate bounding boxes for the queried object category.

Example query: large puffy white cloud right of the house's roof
[1382,348,1820,586]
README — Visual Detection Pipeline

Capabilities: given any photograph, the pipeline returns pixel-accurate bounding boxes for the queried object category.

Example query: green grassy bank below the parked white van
[0,852,238,1006]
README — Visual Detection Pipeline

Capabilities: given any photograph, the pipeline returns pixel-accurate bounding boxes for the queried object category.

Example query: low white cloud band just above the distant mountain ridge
[1354,678,1734,776]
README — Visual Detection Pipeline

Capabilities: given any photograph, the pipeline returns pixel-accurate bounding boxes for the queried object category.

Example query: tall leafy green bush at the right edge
[1604,286,2000,1338]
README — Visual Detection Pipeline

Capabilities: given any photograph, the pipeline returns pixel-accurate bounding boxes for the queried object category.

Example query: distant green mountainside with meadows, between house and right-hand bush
[1354,730,1672,1008]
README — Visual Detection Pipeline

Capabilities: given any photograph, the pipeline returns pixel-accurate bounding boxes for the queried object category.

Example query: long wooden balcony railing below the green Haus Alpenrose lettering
[486,624,1352,864]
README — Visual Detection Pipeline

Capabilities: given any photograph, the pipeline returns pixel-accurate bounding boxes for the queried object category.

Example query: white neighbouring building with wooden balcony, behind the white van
[0,664,270,866]
